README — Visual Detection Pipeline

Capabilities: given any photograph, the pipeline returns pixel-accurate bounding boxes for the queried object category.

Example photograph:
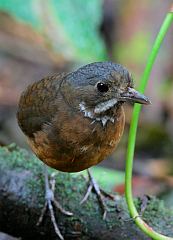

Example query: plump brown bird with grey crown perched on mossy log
[17,61,150,239]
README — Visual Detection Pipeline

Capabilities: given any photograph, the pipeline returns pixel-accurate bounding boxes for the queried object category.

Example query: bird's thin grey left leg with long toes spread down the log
[37,164,73,240]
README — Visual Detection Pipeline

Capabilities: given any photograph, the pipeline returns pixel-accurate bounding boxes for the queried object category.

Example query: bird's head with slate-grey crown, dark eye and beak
[61,62,150,118]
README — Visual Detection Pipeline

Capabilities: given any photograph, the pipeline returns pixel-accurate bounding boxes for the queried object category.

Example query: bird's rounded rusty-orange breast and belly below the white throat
[28,107,125,172]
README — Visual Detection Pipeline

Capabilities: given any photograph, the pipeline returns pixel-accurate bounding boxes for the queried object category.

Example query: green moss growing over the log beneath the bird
[0,144,173,238]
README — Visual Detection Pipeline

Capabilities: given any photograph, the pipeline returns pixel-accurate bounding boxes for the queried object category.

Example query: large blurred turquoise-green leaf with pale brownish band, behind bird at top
[0,0,107,63]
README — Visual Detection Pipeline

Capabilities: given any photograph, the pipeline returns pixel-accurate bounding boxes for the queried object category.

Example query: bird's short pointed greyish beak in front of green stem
[120,87,151,104]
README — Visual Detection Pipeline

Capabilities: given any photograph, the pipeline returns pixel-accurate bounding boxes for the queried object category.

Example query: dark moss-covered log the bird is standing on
[0,145,173,240]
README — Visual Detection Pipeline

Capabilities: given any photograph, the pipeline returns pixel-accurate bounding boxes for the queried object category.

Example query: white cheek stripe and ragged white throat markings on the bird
[79,99,117,127]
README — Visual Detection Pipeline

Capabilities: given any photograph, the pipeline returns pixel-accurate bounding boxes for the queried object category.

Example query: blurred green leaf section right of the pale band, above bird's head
[49,0,107,61]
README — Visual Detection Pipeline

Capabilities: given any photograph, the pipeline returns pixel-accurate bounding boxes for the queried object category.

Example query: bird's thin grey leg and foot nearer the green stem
[80,169,115,219]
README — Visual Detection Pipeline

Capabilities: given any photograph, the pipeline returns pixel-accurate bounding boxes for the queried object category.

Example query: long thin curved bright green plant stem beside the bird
[125,7,173,240]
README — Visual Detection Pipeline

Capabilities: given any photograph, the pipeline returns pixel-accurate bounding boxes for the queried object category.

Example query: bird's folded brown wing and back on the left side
[17,73,67,137]
